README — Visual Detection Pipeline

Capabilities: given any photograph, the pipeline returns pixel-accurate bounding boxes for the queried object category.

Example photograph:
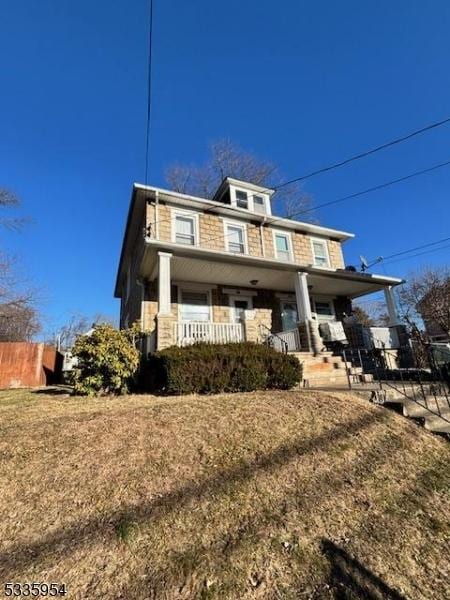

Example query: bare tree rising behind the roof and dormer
[166,139,312,221]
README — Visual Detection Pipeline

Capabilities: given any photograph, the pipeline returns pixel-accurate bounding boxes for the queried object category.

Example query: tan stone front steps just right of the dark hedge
[292,352,372,388]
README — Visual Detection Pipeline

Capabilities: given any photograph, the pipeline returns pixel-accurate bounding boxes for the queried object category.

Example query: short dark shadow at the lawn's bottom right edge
[321,539,405,600]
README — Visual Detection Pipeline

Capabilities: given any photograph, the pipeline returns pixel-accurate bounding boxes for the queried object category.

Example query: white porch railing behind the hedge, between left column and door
[174,321,244,346]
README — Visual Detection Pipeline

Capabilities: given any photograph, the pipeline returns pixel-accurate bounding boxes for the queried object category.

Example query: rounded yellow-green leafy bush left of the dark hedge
[71,324,139,396]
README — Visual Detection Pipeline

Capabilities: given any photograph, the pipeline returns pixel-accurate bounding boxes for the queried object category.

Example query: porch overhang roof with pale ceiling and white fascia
[140,239,403,298]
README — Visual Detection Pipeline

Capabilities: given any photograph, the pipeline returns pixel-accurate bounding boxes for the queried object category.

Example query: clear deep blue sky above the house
[0,0,450,332]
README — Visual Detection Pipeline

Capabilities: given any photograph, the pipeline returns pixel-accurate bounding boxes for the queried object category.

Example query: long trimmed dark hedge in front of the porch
[141,342,301,394]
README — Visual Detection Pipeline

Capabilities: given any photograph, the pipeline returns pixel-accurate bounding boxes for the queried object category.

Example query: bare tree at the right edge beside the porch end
[399,267,450,339]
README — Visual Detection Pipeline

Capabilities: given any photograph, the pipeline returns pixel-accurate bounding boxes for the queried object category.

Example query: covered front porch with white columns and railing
[142,251,399,353]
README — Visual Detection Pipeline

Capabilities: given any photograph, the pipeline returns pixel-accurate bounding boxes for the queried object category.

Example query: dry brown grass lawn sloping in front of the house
[0,390,450,600]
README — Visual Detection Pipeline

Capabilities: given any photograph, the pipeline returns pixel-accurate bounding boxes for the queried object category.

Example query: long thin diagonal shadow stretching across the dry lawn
[0,411,387,574]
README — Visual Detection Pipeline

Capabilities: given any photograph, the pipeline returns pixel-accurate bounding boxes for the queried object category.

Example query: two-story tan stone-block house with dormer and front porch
[115,178,402,352]
